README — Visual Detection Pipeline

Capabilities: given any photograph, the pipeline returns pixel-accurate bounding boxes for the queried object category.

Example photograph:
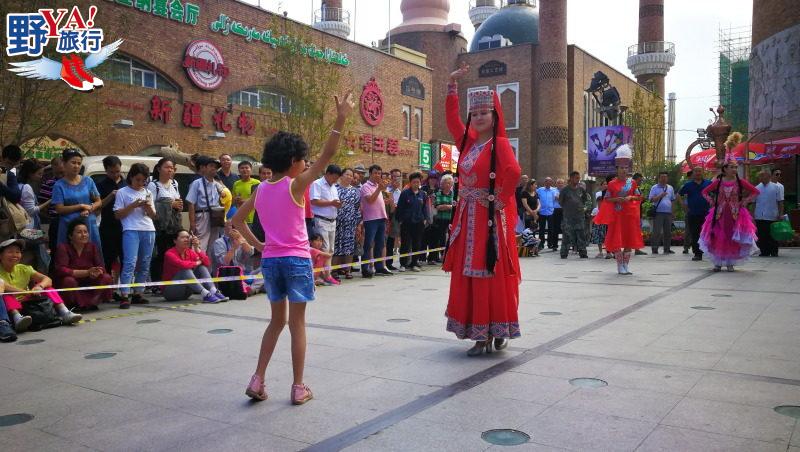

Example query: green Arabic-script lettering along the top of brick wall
[211,14,350,66]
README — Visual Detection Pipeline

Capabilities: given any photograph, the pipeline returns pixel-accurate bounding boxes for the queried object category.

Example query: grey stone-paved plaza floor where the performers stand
[0,250,800,452]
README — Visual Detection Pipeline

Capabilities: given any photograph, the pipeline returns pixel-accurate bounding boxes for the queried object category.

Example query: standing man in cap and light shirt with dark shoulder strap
[186,156,220,255]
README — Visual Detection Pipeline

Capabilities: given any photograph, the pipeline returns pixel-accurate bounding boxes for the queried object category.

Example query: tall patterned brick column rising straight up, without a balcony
[536,0,569,179]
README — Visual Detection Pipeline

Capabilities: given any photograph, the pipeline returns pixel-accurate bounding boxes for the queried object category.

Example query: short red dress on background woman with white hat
[594,178,644,253]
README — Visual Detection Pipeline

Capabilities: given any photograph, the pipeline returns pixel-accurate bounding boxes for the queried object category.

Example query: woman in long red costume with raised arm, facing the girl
[443,65,522,356]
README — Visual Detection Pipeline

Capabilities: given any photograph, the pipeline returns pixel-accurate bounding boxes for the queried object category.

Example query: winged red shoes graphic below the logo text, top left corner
[8,39,123,92]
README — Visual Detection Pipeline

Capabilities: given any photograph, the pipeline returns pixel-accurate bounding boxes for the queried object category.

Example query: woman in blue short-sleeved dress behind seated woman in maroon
[52,149,102,254]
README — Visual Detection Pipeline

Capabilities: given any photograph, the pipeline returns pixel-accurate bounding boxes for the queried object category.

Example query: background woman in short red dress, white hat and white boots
[594,144,644,275]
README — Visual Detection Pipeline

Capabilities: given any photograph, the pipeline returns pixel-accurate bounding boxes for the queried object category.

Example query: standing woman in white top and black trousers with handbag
[147,157,183,281]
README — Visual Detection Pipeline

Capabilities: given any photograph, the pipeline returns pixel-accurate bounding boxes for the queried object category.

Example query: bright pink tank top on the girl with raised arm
[255,177,311,259]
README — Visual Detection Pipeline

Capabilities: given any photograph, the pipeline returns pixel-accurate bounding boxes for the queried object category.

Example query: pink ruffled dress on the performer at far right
[698,178,759,267]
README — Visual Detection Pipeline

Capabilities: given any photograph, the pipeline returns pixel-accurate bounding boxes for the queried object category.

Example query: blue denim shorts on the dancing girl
[261,256,314,303]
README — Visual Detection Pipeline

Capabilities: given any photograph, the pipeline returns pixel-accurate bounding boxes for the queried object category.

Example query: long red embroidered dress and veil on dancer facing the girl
[443,87,522,341]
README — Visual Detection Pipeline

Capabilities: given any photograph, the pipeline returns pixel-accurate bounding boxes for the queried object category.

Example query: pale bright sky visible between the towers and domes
[242,0,753,159]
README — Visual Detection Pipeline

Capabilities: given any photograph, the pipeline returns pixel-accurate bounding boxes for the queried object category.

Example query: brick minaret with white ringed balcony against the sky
[628,0,675,99]
